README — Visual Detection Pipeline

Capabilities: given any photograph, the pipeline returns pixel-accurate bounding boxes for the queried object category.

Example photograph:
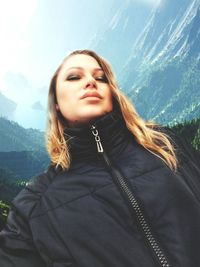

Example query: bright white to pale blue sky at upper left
[0,0,158,129]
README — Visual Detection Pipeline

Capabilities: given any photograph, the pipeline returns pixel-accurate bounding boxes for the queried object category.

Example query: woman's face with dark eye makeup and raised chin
[56,54,113,126]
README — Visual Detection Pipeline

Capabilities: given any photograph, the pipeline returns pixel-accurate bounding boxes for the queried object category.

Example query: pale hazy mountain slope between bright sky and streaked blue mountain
[89,0,151,80]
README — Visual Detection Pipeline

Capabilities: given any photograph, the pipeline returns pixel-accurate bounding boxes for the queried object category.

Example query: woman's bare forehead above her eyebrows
[62,54,100,72]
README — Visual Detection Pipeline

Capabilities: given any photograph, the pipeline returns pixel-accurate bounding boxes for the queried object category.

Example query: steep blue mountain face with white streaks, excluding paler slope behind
[119,0,200,125]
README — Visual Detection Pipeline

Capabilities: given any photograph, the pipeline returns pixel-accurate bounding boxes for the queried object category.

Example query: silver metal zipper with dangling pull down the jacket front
[91,125,171,267]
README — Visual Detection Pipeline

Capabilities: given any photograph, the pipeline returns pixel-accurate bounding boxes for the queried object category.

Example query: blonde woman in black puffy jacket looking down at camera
[0,50,200,267]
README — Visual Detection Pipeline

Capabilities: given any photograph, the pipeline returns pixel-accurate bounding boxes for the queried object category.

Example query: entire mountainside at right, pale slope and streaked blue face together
[91,0,200,125]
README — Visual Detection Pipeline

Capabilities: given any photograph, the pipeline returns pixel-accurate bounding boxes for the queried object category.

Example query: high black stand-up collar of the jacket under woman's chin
[64,110,130,163]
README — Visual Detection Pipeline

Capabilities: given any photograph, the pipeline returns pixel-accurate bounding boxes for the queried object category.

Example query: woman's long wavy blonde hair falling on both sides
[45,50,178,171]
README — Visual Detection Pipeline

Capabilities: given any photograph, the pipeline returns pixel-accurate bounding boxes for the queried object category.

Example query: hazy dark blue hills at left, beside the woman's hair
[0,118,50,179]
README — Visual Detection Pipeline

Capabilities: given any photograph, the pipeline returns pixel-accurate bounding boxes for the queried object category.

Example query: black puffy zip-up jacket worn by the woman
[0,112,200,267]
